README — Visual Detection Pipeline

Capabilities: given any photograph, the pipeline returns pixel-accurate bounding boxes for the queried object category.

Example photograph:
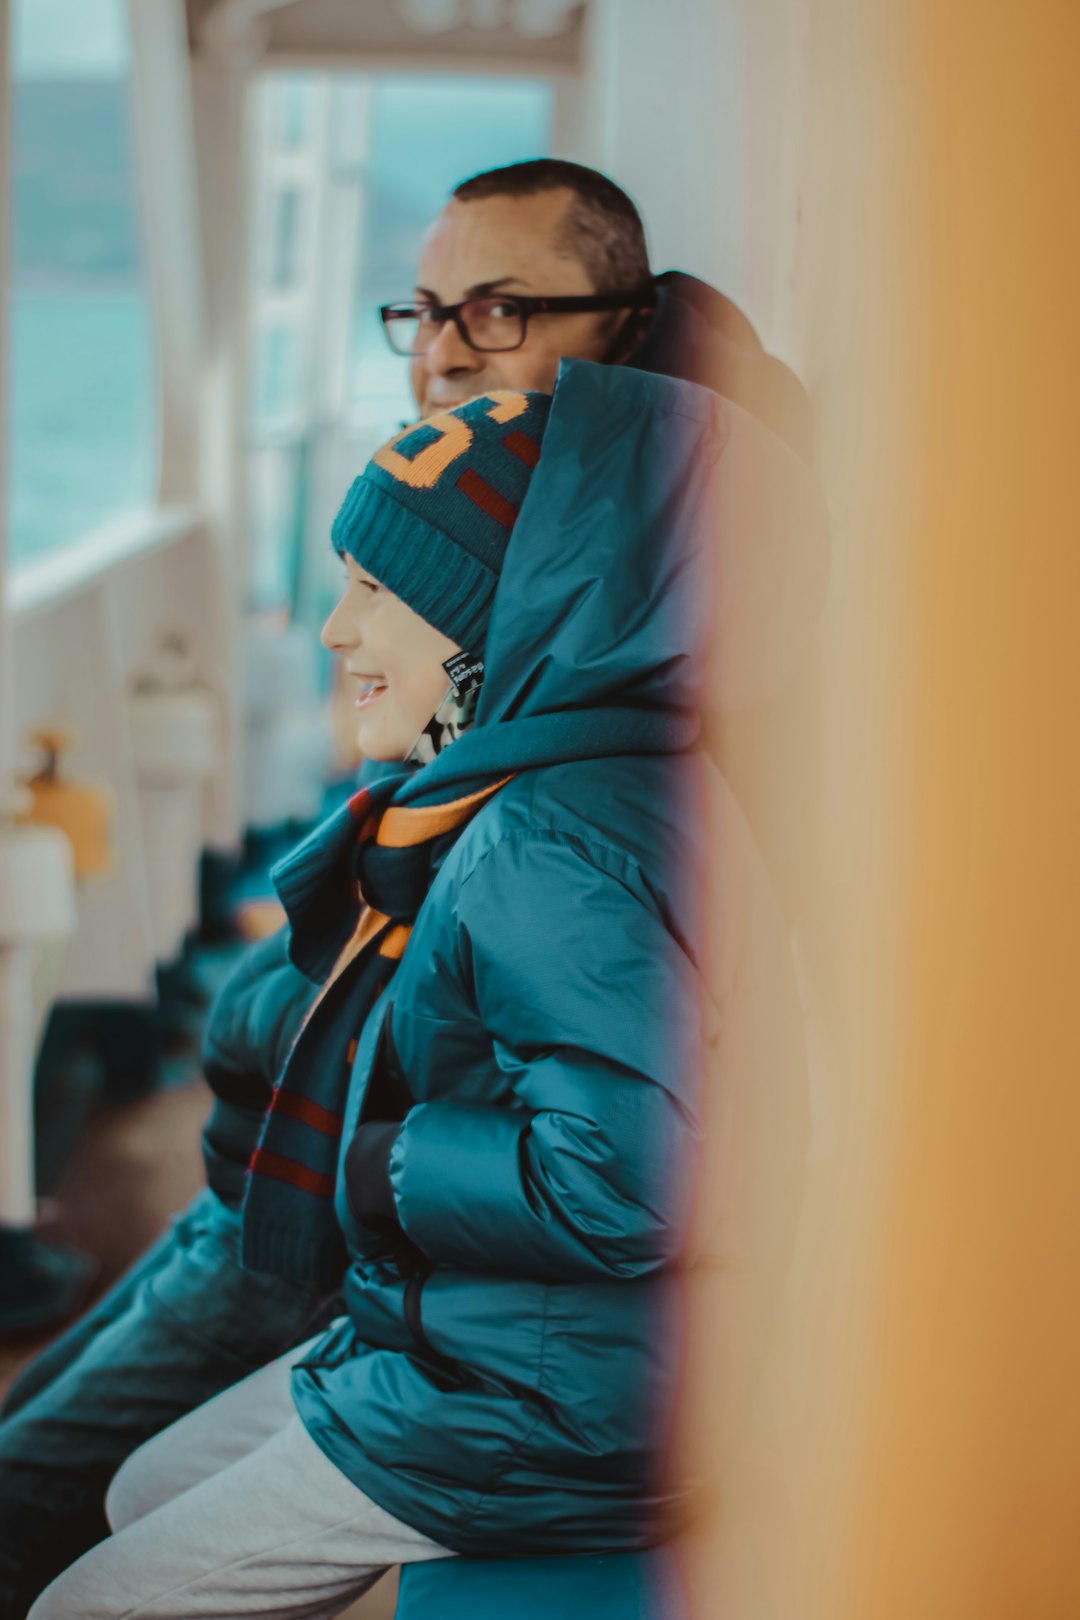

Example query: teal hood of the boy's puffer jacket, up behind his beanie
[476,360,827,747]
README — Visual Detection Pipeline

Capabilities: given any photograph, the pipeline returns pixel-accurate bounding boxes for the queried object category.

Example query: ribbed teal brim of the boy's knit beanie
[330,476,497,653]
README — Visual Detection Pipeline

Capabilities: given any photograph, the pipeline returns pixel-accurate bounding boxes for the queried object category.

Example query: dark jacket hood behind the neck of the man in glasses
[623,271,813,465]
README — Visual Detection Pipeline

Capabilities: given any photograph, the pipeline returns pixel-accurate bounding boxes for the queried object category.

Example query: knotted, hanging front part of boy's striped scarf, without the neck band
[243,773,507,1288]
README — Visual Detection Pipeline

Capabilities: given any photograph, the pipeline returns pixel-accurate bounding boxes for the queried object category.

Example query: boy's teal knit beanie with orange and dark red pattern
[330,390,551,653]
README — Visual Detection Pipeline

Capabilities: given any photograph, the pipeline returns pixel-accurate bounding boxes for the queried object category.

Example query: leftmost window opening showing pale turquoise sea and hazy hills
[8,0,157,565]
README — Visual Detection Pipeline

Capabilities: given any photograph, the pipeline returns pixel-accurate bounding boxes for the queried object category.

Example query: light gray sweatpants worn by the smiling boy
[28,1340,452,1620]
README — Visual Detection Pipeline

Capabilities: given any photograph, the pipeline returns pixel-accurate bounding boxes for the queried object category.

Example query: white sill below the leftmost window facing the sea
[6,507,202,619]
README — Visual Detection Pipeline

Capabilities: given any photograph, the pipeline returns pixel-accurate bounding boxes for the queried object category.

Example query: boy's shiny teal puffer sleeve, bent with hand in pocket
[389,834,699,1281]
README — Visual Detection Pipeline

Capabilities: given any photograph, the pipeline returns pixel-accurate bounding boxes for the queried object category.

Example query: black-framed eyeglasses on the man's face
[379,287,656,355]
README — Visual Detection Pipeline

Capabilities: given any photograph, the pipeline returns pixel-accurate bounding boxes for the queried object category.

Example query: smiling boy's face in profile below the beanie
[322,557,460,760]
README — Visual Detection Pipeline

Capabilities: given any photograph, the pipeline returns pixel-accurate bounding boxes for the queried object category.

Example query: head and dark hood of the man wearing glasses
[379,157,811,462]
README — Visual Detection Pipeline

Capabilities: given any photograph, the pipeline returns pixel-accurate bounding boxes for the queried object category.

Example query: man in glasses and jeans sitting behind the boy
[0,159,810,1620]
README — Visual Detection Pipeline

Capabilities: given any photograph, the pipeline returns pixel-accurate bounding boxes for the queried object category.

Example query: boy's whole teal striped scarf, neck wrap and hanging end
[243,706,698,1290]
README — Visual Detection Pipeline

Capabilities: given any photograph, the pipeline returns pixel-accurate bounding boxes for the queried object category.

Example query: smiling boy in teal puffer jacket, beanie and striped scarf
[32,363,773,1620]
